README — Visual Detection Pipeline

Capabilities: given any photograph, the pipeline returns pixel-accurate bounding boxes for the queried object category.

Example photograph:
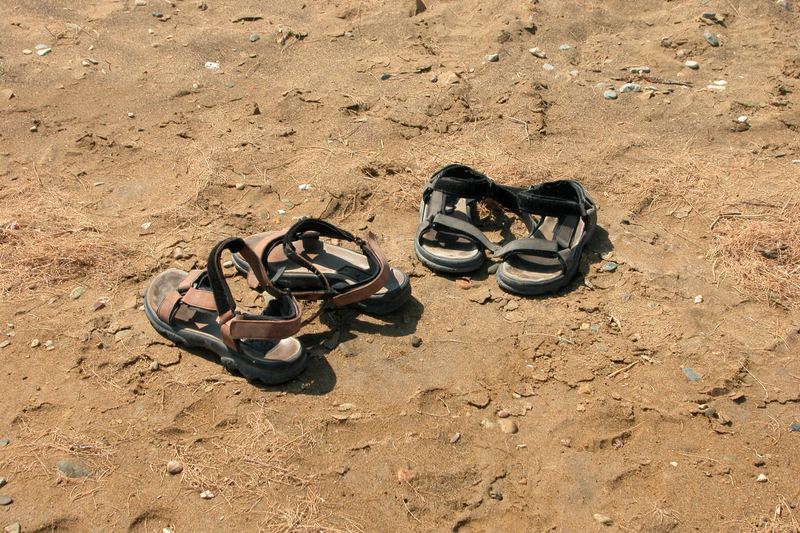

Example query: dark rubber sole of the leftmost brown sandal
[144,290,308,385]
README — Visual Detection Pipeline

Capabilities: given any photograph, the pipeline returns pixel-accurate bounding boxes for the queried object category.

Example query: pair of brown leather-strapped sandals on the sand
[144,219,411,385]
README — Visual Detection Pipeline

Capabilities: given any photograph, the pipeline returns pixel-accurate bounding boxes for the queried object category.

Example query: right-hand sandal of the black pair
[494,180,597,296]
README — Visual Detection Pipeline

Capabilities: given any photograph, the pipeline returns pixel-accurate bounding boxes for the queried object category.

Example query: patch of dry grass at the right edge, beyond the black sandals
[709,202,800,308]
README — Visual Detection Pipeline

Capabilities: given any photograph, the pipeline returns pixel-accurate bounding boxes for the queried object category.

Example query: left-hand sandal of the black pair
[414,164,532,274]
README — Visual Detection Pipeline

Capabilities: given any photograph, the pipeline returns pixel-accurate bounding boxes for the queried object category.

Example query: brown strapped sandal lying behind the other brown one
[233,218,411,315]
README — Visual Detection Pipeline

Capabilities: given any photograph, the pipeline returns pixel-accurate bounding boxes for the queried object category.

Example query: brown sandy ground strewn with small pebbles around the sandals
[0,0,800,533]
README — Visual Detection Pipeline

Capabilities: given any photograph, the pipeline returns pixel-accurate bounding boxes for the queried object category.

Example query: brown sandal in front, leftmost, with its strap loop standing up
[144,238,306,385]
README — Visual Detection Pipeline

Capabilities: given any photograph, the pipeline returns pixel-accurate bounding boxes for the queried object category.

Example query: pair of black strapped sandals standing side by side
[414,164,597,296]
